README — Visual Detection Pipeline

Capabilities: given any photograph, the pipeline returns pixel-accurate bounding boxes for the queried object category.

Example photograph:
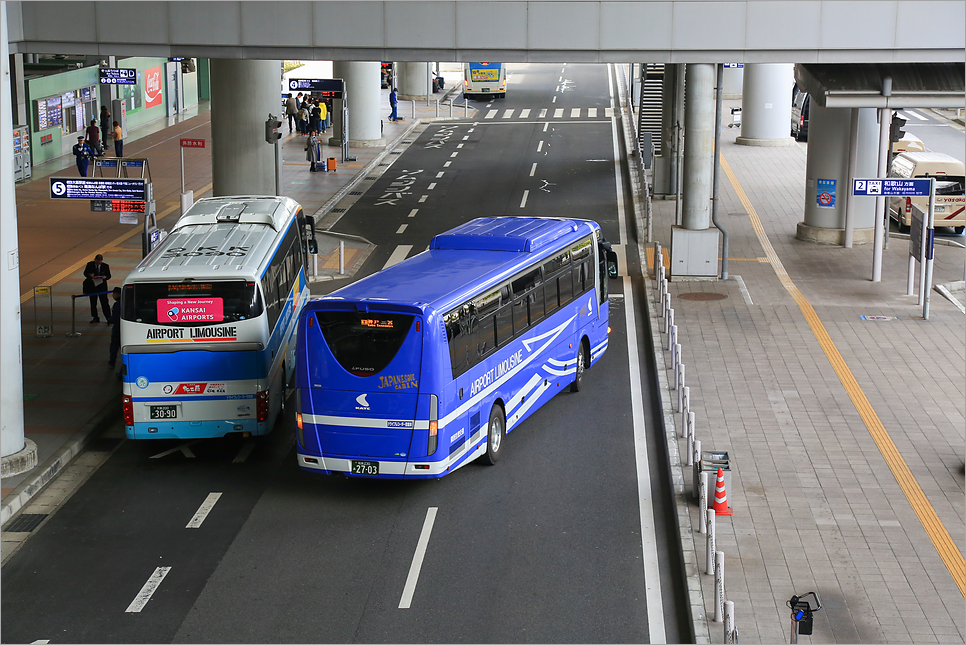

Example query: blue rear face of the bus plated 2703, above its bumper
[301,310,425,460]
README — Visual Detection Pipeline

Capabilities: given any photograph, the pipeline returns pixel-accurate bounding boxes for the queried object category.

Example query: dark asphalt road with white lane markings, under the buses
[2,65,690,643]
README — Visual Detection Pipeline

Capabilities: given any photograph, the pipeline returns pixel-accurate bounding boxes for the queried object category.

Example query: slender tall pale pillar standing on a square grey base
[681,63,715,230]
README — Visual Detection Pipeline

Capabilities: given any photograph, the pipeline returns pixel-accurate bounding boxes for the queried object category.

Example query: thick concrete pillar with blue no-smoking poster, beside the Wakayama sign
[796,101,879,244]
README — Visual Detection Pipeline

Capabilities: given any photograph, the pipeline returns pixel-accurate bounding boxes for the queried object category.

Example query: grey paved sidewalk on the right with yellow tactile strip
[646,100,966,643]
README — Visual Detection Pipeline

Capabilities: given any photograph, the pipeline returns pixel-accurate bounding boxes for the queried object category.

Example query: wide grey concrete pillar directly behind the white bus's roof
[211,59,285,196]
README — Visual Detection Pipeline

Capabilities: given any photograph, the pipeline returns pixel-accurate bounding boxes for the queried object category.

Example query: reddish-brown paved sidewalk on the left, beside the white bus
[0,78,474,528]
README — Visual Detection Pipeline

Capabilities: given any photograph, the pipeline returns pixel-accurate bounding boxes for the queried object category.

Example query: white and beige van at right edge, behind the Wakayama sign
[889,152,966,233]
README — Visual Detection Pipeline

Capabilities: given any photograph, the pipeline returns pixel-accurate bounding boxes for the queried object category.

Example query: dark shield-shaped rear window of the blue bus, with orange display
[315,311,413,376]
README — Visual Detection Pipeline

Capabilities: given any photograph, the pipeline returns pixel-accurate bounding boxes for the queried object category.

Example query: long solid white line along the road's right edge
[607,64,667,643]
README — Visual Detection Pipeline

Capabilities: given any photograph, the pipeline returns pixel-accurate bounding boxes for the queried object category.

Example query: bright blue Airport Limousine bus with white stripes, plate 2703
[295,217,616,478]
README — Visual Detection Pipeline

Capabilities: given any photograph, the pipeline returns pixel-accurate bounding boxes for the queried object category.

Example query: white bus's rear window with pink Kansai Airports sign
[121,280,262,327]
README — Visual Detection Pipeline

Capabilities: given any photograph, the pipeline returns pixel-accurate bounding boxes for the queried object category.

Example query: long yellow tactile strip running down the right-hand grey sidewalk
[721,155,966,596]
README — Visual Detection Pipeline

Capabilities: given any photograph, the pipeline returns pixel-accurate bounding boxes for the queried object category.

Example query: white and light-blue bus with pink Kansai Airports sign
[121,196,316,439]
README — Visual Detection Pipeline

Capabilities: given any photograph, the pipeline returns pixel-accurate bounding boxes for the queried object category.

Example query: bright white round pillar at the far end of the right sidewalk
[735,63,795,146]
